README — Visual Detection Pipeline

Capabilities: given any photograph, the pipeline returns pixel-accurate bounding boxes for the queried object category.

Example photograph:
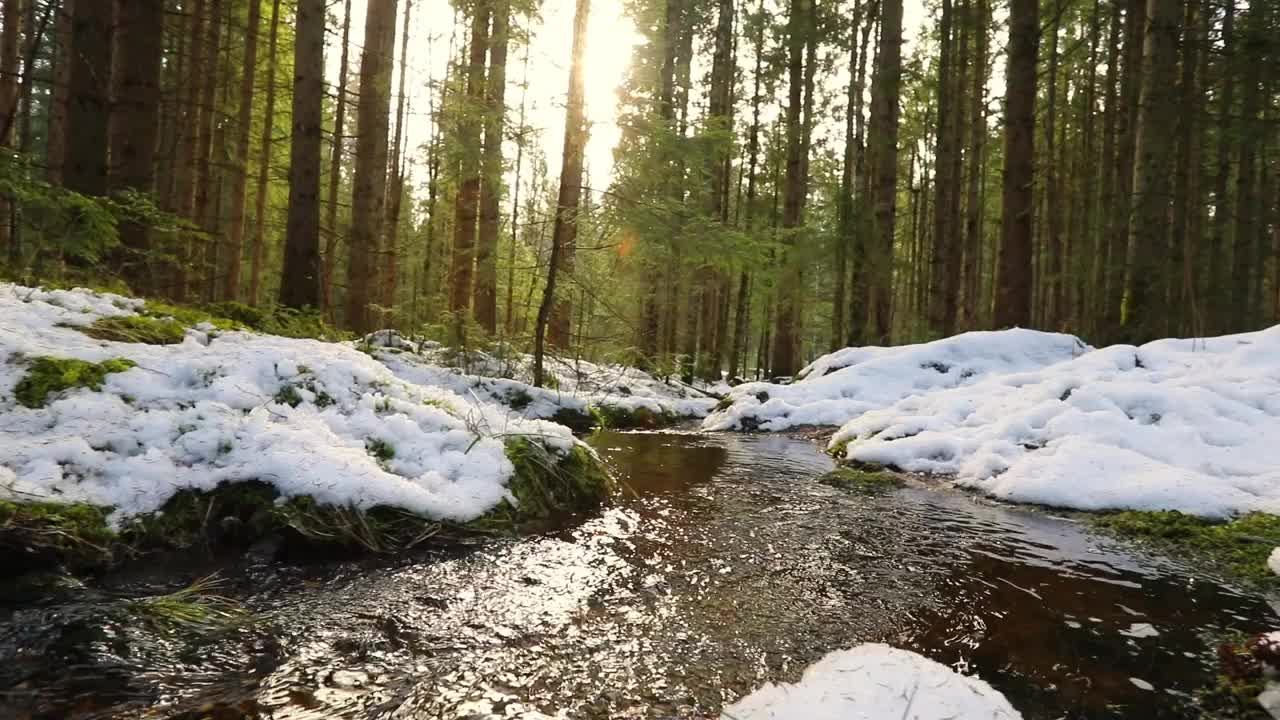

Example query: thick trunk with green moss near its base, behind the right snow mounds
[1124,0,1180,342]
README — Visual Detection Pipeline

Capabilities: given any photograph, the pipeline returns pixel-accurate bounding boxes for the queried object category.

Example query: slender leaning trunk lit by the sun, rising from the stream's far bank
[534,0,591,387]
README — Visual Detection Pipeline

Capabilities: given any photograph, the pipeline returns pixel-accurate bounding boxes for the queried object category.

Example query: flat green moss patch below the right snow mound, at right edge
[1094,510,1280,587]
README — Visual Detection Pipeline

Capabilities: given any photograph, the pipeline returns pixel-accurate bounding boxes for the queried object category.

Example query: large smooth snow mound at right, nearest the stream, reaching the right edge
[831,325,1280,518]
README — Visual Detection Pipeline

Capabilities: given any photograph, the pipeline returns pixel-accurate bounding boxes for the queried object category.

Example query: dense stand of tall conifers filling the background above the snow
[0,0,1280,379]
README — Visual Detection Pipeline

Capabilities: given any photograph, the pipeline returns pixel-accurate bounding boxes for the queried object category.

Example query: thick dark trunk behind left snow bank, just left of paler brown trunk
[277,0,325,304]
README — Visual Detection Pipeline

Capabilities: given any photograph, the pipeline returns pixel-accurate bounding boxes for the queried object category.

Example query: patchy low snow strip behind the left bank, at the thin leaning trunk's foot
[375,331,727,418]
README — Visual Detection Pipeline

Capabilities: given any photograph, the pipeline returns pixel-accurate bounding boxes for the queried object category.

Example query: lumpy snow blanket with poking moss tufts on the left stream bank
[0,284,576,521]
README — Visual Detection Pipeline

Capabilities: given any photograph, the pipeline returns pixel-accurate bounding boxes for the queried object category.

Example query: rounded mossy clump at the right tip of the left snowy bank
[467,437,614,532]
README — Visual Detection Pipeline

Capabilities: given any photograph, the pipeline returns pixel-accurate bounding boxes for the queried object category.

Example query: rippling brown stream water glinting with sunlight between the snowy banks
[0,433,1280,720]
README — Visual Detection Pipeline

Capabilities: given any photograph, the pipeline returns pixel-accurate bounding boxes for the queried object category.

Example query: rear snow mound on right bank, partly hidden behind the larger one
[703,329,1089,430]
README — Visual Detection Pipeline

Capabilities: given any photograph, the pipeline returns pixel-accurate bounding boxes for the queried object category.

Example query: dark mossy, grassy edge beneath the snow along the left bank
[0,438,614,577]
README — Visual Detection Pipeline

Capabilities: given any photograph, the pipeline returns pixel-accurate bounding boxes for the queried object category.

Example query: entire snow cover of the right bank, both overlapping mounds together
[703,327,1280,518]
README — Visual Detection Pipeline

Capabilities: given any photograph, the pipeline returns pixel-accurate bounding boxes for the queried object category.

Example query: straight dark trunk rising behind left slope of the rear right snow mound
[867,0,906,345]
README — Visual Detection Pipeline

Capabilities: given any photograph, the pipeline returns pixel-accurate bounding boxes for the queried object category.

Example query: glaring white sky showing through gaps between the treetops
[326,0,925,187]
